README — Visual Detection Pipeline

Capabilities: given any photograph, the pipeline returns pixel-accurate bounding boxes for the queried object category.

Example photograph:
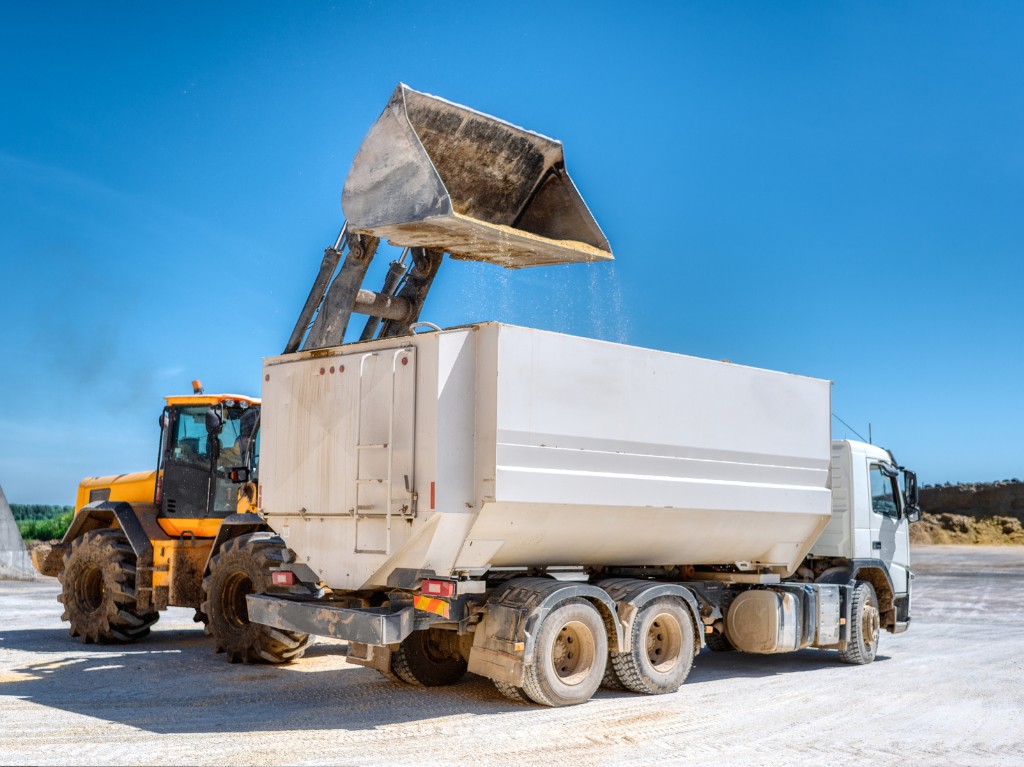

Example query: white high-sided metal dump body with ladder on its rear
[260,323,830,590]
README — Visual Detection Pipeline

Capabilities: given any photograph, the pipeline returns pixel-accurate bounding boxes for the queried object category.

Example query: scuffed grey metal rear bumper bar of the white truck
[246,594,416,645]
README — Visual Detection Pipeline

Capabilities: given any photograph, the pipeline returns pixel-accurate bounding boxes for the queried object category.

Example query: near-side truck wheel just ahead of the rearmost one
[611,597,693,695]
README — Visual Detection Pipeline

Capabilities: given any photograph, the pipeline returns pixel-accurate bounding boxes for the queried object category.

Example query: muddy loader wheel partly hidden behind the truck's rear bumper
[200,532,309,664]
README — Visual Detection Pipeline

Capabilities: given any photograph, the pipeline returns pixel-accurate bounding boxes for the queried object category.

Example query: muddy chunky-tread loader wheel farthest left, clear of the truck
[57,528,160,644]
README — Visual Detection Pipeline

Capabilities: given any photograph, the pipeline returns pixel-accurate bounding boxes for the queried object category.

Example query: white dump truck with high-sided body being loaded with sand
[235,323,915,706]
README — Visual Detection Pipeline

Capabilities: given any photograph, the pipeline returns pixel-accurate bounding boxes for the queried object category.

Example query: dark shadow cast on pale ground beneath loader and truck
[0,629,886,734]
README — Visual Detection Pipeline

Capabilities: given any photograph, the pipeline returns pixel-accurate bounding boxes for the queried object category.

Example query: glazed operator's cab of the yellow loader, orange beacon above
[155,394,259,537]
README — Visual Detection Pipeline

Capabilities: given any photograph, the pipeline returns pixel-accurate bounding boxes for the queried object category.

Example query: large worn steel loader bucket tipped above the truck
[341,84,611,268]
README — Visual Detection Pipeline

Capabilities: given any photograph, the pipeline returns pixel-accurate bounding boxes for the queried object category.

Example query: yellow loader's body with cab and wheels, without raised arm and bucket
[34,381,308,663]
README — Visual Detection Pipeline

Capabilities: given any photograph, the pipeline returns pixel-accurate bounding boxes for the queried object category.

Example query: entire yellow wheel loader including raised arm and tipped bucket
[36,84,611,663]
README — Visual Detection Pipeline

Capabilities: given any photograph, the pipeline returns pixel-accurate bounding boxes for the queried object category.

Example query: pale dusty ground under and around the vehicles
[0,546,1024,767]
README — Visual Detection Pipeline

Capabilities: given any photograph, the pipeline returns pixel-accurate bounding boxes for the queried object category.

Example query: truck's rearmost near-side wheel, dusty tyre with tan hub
[522,599,608,706]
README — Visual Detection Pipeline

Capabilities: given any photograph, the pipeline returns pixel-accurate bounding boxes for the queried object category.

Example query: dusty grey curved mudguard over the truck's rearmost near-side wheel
[469,578,623,686]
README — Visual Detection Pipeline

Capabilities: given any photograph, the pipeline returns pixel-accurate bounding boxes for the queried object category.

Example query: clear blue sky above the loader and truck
[0,2,1024,504]
